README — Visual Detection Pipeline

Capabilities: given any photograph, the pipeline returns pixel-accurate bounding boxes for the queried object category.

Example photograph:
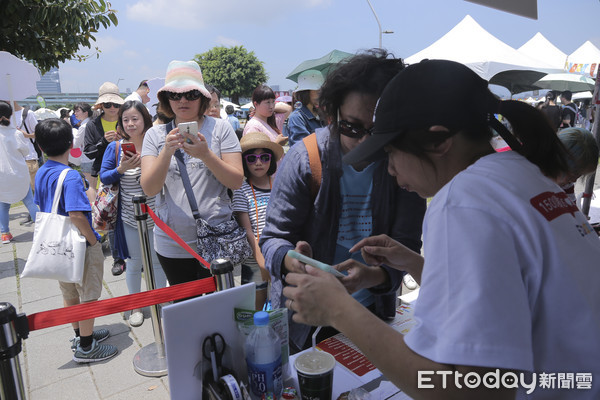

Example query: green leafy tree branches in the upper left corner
[0,0,118,73]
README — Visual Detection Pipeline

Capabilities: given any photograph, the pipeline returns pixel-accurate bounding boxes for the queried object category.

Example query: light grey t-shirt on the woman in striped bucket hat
[142,117,242,258]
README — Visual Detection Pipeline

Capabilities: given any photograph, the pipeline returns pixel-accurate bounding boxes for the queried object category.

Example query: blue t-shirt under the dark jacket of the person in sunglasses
[334,163,378,307]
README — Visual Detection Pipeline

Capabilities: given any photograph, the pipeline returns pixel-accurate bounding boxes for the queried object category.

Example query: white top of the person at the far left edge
[0,125,31,204]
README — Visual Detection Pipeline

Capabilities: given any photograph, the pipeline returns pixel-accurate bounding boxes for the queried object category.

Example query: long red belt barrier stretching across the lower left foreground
[27,277,217,331]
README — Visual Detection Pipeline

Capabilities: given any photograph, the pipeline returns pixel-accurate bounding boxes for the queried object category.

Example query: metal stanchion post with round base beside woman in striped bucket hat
[133,195,167,376]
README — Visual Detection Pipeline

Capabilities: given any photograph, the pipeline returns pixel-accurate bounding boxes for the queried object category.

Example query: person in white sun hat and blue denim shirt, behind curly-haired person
[288,69,325,147]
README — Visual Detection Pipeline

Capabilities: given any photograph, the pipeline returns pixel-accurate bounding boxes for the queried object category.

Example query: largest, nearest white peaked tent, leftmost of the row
[406,15,562,80]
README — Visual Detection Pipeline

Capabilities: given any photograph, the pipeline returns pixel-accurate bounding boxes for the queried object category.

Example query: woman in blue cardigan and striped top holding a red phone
[100,100,167,326]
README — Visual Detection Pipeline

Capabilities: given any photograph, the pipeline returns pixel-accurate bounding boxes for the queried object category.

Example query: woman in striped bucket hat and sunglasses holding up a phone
[140,61,244,285]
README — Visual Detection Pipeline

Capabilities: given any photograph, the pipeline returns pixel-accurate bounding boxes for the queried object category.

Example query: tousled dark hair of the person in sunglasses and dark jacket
[318,49,404,130]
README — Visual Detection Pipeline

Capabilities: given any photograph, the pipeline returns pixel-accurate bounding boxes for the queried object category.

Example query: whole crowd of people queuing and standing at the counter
[0,50,600,399]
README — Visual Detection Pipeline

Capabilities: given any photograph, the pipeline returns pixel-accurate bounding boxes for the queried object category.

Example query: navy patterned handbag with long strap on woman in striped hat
[175,150,252,265]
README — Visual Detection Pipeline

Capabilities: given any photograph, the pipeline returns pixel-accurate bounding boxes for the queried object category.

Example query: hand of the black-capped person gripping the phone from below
[283,264,352,326]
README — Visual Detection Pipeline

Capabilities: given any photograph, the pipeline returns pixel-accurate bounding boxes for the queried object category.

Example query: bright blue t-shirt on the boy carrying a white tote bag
[34,160,100,240]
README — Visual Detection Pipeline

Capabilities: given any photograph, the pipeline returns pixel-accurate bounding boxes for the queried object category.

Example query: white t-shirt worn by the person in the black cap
[405,152,600,399]
